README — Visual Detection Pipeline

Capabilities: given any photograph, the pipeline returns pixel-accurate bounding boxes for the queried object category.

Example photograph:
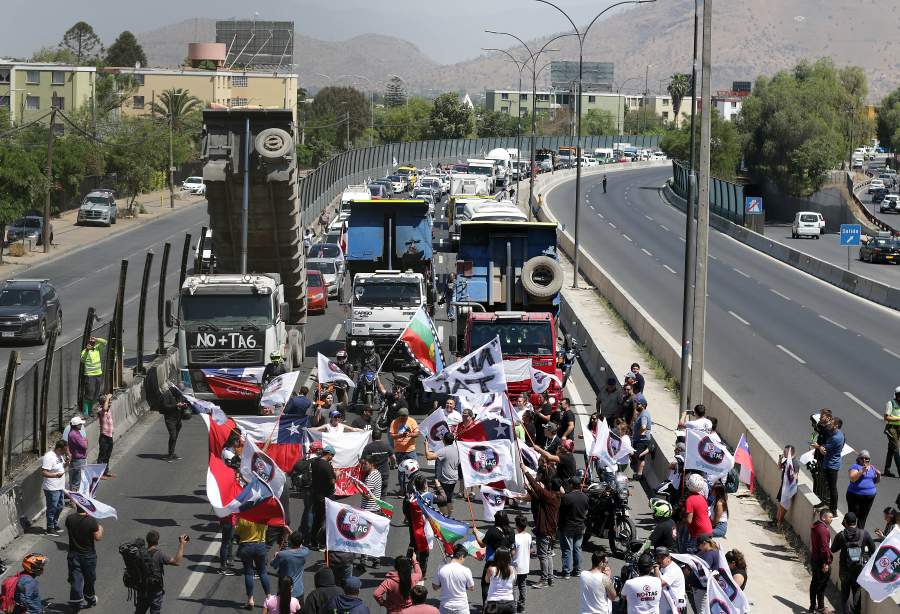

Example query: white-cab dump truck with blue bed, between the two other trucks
[344,199,436,366]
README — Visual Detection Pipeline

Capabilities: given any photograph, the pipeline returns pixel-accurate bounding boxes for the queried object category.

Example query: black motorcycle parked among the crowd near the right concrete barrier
[584,473,637,555]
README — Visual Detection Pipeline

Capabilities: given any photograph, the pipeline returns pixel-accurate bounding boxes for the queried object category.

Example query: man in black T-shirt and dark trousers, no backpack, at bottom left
[66,500,103,612]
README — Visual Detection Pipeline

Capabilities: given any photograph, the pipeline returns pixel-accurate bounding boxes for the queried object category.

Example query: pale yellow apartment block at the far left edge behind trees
[0,60,97,132]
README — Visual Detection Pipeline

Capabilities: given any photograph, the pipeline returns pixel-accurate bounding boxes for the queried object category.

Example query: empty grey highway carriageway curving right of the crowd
[545,168,900,522]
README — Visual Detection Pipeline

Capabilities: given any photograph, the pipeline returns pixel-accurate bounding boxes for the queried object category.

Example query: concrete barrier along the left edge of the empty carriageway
[539,173,900,614]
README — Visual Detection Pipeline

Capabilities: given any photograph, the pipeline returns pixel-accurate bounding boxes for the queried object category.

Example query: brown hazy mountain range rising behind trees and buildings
[138,0,900,101]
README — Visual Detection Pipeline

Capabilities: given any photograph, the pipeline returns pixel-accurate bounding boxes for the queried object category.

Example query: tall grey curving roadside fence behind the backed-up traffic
[299,135,659,225]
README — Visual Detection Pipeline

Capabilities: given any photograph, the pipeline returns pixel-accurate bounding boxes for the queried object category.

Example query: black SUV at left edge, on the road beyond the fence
[0,279,62,344]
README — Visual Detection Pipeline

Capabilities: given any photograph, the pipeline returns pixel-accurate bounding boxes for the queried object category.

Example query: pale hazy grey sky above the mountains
[0,0,624,63]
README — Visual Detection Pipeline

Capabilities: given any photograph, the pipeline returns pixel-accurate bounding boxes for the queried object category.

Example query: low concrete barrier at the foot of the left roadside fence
[0,350,178,548]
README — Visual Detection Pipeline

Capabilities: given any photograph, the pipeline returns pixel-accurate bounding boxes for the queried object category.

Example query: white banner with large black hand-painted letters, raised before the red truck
[422,337,506,397]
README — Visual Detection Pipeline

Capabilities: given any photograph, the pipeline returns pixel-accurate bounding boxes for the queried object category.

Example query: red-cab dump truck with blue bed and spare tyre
[449,221,563,399]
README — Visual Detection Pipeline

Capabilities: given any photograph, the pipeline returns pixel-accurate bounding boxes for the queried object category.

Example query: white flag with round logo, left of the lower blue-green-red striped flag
[325,499,391,556]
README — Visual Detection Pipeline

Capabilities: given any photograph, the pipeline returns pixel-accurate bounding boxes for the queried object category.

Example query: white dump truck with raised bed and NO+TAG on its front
[166,109,306,403]
